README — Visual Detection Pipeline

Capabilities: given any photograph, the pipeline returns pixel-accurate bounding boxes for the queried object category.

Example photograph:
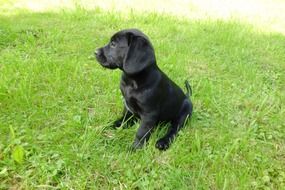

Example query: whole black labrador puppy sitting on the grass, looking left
[95,29,192,150]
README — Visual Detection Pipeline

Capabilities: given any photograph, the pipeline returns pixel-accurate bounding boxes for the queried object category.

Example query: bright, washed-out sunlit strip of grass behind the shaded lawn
[0,0,285,34]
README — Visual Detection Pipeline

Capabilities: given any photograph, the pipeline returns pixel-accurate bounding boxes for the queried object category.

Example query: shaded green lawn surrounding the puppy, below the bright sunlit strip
[0,2,285,190]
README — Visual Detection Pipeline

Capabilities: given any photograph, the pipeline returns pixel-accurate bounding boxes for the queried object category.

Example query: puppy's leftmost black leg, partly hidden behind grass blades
[111,107,137,128]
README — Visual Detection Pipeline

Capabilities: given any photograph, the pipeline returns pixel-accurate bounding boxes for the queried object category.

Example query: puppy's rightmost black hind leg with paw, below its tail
[155,100,192,150]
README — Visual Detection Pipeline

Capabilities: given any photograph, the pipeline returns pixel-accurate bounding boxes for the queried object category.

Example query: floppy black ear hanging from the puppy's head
[123,34,155,74]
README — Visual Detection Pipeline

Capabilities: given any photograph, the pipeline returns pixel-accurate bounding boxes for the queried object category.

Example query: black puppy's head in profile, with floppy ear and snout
[95,29,156,75]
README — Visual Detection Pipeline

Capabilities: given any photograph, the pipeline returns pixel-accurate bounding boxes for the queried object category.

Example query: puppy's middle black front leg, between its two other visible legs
[132,119,156,149]
